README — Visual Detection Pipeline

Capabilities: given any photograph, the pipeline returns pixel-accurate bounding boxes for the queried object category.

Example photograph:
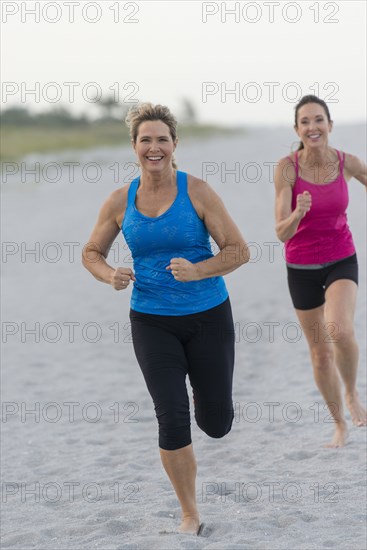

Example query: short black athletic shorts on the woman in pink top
[287,254,358,310]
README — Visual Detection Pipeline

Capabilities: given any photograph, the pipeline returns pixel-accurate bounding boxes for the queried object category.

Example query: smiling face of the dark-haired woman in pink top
[295,103,333,149]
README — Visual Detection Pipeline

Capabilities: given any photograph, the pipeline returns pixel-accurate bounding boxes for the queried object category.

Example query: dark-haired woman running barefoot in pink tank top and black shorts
[275,95,367,447]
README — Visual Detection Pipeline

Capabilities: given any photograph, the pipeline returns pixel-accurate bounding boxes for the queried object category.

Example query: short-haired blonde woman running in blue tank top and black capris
[83,103,249,534]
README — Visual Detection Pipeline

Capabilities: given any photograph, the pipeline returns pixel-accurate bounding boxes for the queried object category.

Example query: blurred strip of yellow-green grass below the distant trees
[0,122,245,162]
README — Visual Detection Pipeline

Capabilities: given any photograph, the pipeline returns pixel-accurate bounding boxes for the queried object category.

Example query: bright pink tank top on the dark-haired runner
[285,151,355,265]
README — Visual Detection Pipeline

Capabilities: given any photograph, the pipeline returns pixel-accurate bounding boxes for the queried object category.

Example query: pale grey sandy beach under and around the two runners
[1,125,366,550]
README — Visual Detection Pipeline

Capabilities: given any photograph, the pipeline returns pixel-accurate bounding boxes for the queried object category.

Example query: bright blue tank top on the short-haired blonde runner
[121,171,228,315]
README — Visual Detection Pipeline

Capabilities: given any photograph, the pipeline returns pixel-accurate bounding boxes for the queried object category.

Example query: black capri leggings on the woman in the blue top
[130,298,235,450]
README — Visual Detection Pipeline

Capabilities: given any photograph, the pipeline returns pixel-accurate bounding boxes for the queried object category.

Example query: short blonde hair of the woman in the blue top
[125,103,177,168]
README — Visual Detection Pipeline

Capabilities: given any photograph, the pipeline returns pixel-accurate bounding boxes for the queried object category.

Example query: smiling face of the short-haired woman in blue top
[133,120,177,172]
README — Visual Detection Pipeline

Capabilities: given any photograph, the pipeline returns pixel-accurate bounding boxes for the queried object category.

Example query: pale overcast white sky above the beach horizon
[1,0,367,126]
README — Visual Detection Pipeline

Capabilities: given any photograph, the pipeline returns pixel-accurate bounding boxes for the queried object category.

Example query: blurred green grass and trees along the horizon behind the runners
[0,104,246,161]
